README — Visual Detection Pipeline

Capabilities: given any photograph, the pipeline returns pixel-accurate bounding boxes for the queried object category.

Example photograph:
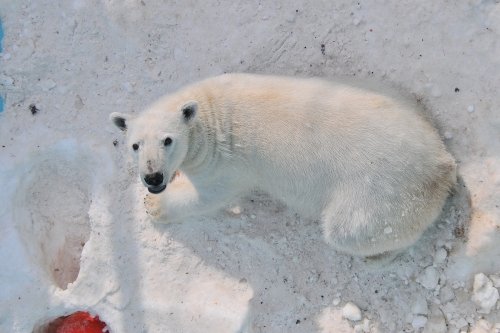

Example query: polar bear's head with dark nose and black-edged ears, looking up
[110,101,198,194]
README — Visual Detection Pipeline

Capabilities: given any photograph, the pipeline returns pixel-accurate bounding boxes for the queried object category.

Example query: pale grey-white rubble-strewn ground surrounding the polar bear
[0,0,500,333]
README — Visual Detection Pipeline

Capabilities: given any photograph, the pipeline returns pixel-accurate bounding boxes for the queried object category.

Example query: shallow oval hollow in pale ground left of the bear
[14,142,95,289]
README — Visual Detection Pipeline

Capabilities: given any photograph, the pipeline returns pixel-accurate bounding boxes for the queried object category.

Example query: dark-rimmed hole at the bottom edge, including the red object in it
[33,311,109,333]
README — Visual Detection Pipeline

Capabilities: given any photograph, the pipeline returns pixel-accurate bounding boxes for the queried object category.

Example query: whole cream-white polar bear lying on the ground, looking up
[110,74,456,258]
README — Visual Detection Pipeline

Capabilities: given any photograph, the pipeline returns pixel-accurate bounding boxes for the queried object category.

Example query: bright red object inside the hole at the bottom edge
[54,311,109,333]
